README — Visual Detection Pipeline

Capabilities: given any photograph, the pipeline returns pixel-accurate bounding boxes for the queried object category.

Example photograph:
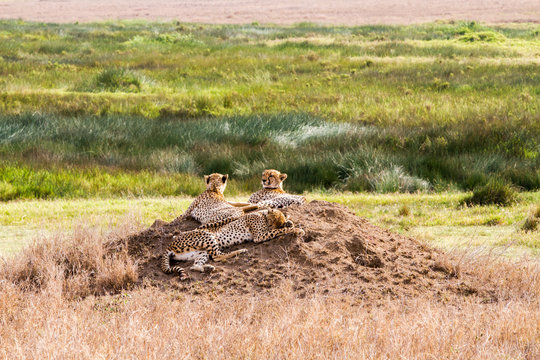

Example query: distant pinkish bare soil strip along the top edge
[0,0,540,25]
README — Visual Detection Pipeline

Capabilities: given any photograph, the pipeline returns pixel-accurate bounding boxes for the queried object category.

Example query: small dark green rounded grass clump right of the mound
[463,179,517,206]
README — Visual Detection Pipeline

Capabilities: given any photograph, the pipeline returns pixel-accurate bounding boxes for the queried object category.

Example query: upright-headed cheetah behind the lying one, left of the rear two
[181,173,259,224]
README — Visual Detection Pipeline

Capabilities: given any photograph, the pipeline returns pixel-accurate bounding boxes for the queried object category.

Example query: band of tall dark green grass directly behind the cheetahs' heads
[0,113,540,200]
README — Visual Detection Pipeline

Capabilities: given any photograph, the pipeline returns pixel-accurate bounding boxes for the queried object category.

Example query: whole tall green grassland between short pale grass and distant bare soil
[0,21,540,200]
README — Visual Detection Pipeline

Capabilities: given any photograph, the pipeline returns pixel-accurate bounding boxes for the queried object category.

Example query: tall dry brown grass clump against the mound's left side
[0,221,138,299]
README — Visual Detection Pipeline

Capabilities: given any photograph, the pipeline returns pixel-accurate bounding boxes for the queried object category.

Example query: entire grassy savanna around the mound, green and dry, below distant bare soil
[0,20,540,359]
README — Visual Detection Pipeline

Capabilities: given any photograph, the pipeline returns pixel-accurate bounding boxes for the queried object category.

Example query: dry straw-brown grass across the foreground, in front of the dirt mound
[0,218,540,359]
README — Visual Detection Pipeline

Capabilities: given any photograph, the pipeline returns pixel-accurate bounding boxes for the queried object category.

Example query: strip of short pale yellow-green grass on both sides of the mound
[0,192,540,257]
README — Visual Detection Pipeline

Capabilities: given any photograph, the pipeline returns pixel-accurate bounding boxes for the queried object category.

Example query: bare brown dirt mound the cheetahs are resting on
[128,201,489,299]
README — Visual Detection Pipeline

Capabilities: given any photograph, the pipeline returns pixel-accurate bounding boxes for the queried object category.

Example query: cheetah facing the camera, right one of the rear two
[248,170,306,208]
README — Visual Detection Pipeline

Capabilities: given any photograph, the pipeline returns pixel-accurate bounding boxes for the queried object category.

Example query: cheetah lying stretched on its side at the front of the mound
[161,209,304,280]
